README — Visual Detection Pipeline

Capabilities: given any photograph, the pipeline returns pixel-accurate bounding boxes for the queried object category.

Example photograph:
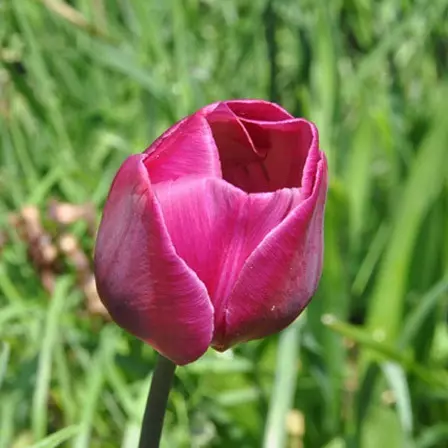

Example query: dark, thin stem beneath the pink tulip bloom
[138,355,176,448]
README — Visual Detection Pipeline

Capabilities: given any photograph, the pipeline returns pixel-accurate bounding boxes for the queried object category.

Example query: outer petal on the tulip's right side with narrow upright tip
[214,142,327,350]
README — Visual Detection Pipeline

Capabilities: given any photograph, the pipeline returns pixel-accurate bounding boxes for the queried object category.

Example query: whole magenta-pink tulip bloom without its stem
[95,100,327,365]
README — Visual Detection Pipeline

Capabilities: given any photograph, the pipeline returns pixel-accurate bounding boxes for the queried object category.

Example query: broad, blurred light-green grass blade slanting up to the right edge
[367,89,448,342]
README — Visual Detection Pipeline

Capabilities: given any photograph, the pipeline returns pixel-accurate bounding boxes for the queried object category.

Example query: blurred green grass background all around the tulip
[0,0,448,448]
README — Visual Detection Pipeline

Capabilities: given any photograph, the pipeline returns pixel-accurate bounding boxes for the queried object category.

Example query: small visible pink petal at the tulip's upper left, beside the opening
[144,113,222,184]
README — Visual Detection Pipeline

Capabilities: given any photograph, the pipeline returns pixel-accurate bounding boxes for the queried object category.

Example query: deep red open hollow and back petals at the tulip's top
[206,101,317,193]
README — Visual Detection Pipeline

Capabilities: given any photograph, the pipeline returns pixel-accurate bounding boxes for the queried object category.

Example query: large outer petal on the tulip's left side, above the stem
[95,155,213,365]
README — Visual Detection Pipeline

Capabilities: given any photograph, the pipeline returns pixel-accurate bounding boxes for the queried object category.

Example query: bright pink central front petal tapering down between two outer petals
[154,178,300,339]
